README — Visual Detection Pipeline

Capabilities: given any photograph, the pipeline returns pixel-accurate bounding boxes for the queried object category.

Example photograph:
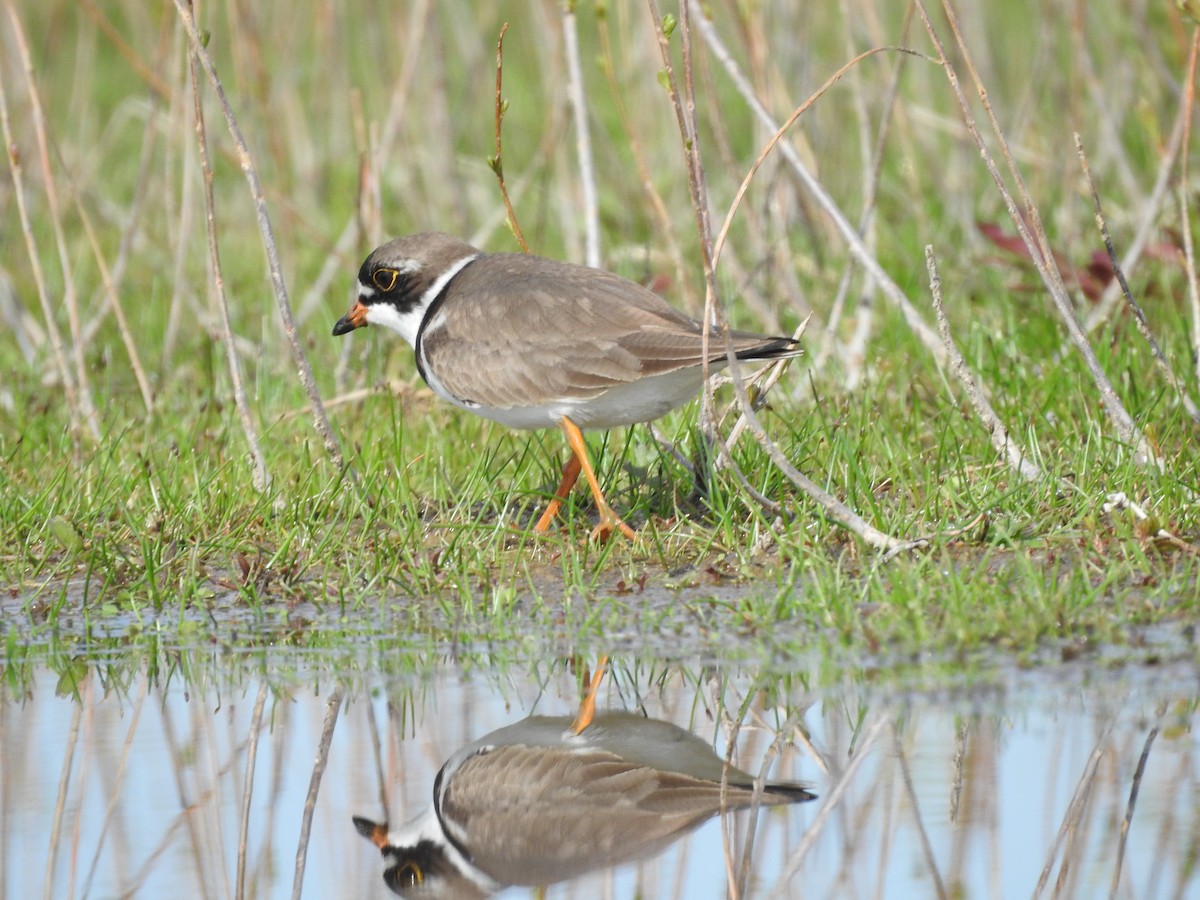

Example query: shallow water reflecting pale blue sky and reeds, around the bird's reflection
[0,650,1200,898]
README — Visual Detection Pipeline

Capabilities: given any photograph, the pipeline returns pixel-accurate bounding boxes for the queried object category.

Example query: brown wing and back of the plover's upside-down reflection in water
[442,746,751,884]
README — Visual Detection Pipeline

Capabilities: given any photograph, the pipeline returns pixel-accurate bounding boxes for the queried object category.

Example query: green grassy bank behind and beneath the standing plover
[0,0,1200,668]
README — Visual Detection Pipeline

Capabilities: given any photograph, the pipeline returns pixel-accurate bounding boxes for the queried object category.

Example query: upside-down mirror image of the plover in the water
[354,662,815,898]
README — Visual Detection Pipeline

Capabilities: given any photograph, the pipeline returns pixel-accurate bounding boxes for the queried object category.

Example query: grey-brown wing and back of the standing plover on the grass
[421,253,775,408]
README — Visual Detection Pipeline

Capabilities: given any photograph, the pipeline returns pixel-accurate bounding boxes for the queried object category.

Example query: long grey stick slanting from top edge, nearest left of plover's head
[175,0,346,469]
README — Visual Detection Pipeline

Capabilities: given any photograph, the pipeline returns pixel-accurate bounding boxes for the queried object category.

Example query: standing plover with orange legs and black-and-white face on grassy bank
[334,232,800,540]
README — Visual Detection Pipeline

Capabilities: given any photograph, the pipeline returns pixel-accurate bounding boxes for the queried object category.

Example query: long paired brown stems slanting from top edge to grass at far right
[916,0,1162,467]
